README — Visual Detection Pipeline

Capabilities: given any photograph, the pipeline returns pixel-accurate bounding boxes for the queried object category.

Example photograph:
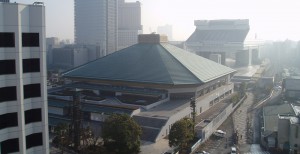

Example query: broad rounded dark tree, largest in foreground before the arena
[102,114,142,154]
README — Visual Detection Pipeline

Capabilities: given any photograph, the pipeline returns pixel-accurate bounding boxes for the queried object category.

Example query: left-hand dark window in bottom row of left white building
[0,138,19,154]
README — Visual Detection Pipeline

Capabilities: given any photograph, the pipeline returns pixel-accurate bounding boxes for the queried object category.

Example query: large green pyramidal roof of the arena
[63,43,235,85]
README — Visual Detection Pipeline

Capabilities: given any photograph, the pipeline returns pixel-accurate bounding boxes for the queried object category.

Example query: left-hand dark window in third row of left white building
[0,86,17,102]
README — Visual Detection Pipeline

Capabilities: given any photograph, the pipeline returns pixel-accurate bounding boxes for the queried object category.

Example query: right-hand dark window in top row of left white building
[22,33,40,47]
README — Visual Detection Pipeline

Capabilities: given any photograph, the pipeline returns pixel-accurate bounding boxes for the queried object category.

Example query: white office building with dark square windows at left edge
[0,3,49,154]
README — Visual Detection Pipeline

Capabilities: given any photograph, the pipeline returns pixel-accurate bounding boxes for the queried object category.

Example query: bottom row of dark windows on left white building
[0,133,43,154]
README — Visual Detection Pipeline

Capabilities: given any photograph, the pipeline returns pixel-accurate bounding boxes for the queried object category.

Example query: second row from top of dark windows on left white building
[0,58,40,75]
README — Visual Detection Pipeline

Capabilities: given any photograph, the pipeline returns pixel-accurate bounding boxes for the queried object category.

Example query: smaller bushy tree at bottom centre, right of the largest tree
[169,118,194,151]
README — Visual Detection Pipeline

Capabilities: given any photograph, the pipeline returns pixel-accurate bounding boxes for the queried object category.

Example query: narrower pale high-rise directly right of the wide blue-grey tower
[118,0,142,50]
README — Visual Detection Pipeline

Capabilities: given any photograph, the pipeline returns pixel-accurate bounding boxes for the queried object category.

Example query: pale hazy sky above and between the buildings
[15,0,300,40]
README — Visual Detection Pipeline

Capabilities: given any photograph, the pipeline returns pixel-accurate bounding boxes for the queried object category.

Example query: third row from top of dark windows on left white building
[0,83,41,103]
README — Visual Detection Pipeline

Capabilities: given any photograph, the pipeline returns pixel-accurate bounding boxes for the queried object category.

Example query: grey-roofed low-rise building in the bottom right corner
[261,103,300,154]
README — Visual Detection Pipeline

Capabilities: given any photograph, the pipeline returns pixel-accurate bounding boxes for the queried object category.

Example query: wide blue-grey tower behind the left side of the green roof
[74,0,118,54]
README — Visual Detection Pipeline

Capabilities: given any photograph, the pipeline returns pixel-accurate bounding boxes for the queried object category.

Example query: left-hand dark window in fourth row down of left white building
[0,112,18,130]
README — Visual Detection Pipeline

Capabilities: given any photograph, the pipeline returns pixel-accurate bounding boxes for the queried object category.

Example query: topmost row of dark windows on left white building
[0,32,40,48]
